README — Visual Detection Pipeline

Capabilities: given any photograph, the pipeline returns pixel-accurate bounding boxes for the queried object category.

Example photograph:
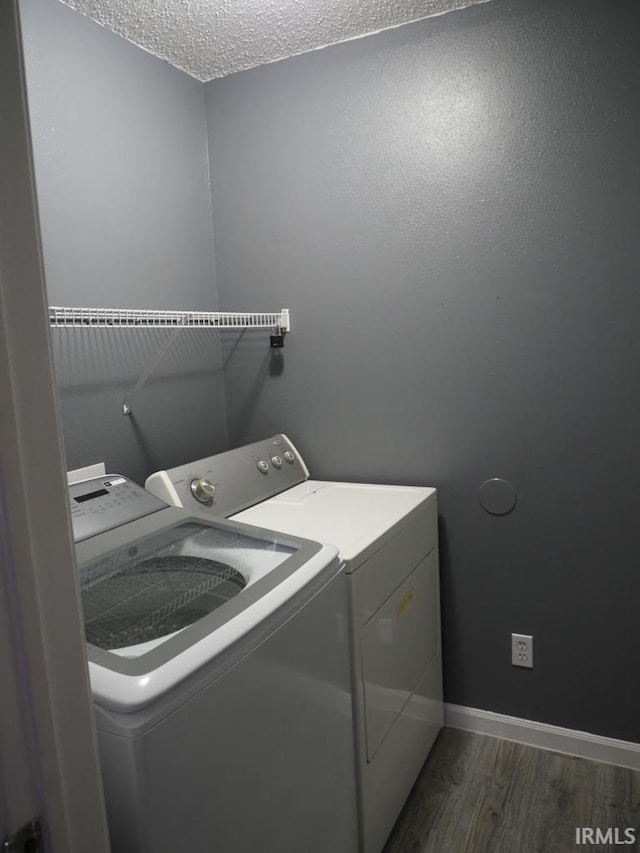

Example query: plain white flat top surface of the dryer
[233,480,436,570]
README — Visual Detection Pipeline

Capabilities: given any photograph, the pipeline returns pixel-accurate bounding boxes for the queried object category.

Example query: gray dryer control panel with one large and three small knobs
[145,434,309,518]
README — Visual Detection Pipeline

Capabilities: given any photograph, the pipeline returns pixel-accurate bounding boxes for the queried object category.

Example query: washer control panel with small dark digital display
[69,474,167,542]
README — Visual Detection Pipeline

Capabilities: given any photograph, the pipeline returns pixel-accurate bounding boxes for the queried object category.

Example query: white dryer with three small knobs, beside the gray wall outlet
[146,435,443,853]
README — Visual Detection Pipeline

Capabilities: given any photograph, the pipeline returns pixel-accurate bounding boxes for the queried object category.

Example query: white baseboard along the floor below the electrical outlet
[444,704,640,770]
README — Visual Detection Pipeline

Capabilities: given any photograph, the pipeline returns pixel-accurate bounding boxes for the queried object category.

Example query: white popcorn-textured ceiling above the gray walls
[62,0,487,81]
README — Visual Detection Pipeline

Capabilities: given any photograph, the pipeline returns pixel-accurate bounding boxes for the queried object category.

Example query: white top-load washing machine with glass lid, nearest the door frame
[69,475,357,853]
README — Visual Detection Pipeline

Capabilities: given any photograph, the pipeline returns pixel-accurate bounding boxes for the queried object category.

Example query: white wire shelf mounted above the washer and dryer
[49,305,291,332]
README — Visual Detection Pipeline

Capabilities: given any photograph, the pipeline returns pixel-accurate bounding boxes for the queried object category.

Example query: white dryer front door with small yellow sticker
[362,550,439,761]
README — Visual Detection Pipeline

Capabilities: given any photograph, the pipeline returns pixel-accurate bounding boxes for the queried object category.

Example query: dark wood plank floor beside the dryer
[383,729,640,853]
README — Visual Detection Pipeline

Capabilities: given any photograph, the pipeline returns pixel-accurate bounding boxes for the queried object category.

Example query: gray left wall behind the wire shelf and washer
[21,0,227,482]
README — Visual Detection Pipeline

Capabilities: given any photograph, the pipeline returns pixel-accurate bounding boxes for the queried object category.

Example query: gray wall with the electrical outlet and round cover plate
[206,0,640,741]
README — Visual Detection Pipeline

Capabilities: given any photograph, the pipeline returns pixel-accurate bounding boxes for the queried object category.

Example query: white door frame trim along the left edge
[0,0,109,853]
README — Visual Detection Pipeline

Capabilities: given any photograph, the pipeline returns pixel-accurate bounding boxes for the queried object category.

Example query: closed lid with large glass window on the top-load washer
[76,507,339,711]
